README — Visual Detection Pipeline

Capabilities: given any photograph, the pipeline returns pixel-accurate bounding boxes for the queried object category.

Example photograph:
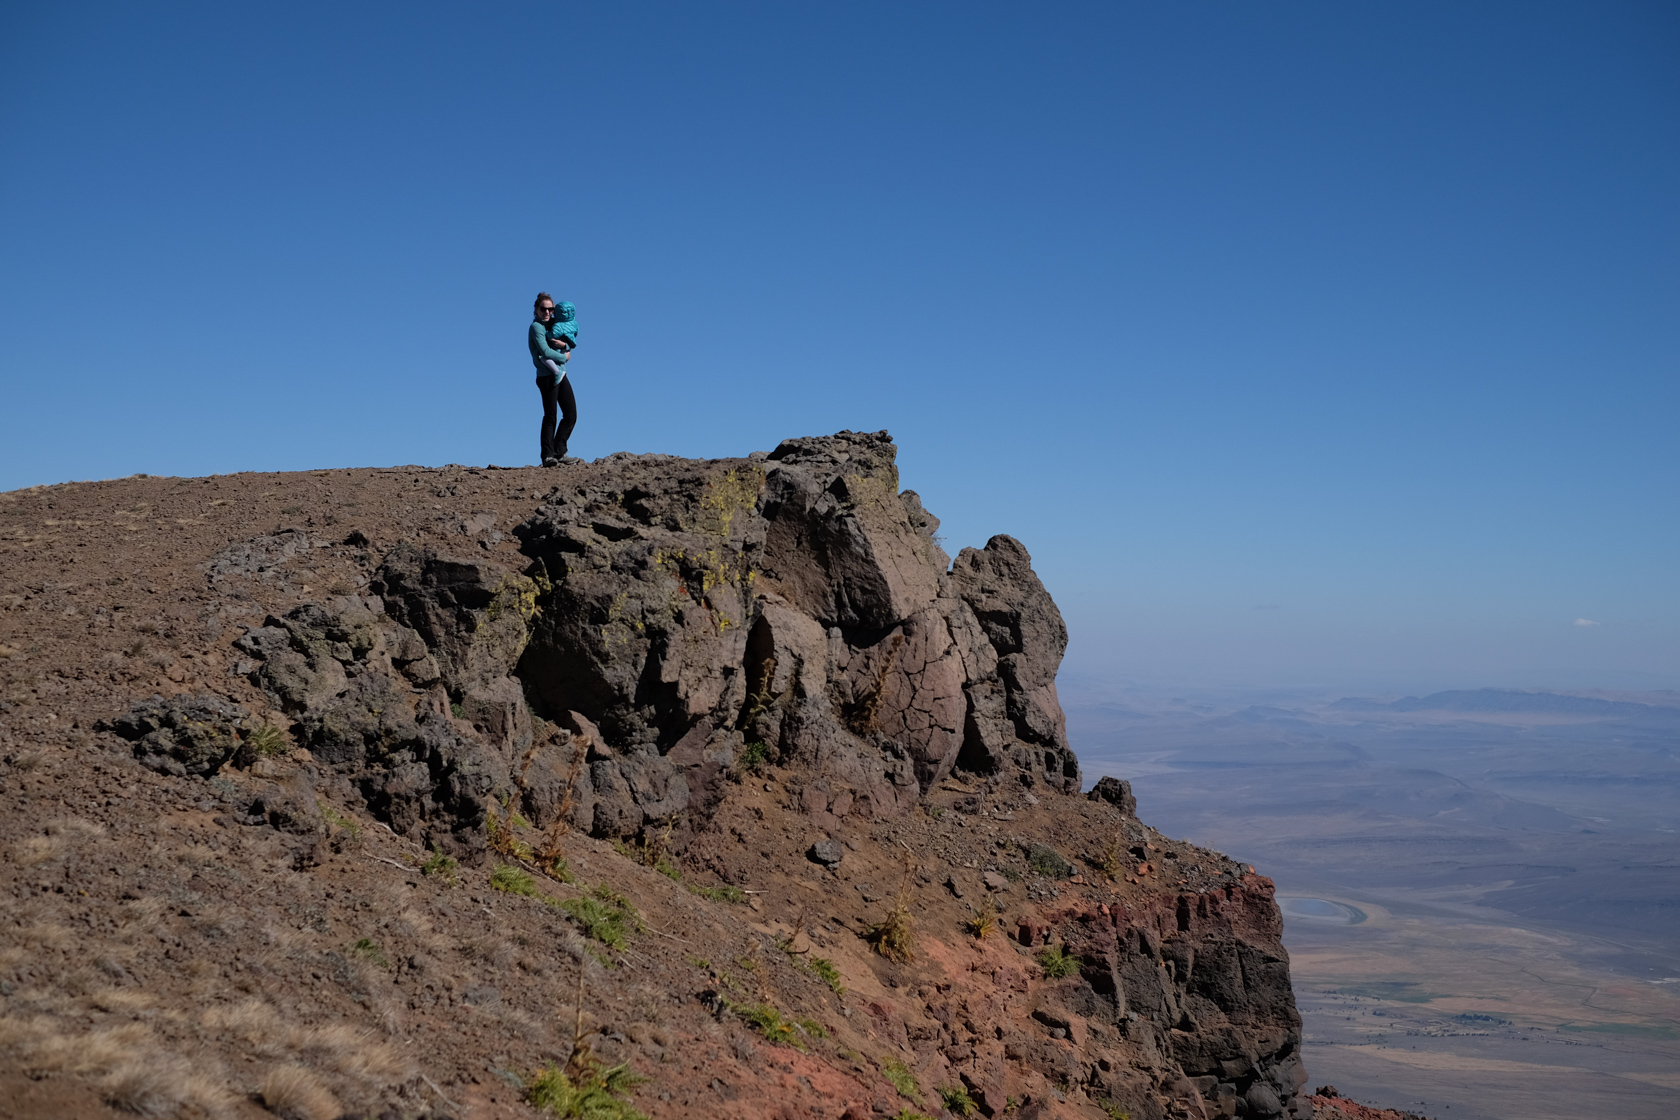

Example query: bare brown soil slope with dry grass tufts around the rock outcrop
[0,467,1275,1120]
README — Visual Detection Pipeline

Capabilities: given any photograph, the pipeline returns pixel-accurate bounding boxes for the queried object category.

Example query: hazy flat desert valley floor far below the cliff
[1063,678,1680,1120]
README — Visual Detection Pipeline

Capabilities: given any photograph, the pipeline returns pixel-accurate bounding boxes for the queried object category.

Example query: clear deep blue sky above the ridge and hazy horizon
[0,2,1680,690]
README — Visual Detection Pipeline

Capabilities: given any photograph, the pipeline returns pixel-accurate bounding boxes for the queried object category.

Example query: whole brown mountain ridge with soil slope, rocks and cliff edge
[0,432,1310,1120]
